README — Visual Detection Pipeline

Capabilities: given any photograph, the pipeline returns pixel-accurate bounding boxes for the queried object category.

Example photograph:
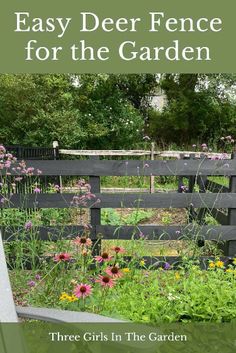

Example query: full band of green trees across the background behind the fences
[0,74,236,149]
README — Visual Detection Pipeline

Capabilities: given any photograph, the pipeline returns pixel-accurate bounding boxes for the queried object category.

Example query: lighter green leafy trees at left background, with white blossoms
[0,74,143,149]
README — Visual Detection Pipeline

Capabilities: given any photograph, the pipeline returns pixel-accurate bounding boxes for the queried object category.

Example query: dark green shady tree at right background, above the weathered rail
[149,74,236,145]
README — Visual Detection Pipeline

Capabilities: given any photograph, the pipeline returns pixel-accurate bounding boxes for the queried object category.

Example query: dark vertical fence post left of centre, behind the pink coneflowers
[89,156,101,255]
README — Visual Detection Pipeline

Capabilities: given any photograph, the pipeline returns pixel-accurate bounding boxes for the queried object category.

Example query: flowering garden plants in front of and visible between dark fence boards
[1,142,236,324]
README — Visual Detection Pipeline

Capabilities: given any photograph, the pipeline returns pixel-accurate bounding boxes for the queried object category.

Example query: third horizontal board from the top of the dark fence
[2,224,236,241]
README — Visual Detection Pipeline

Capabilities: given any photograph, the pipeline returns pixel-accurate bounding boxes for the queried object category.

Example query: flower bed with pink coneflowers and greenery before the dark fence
[12,243,236,323]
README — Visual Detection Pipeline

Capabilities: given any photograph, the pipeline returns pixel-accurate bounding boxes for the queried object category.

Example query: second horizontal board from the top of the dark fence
[3,192,236,209]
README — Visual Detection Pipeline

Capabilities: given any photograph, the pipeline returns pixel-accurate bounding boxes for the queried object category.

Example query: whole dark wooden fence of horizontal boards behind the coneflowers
[1,156,236,265]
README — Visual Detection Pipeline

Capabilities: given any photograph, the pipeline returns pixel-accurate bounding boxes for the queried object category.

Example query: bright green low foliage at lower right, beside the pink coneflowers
[102,266,236,324]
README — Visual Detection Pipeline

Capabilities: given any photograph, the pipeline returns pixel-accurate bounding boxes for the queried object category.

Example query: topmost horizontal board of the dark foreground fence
[5,160,236,176]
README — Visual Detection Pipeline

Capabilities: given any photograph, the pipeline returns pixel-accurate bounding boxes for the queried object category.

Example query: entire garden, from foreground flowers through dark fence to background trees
[0,75,236,325]
